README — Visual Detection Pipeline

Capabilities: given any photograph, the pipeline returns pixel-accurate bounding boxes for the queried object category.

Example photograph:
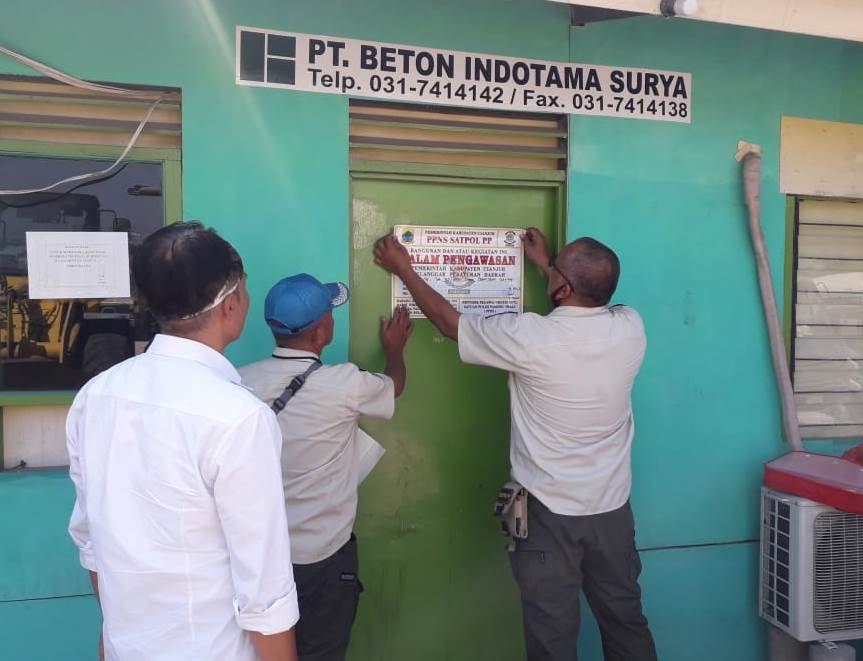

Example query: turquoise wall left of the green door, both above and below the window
[0,0,569,661]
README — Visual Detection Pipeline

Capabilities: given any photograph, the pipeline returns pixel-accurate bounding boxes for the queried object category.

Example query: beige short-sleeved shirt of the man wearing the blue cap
[240,348,395,565]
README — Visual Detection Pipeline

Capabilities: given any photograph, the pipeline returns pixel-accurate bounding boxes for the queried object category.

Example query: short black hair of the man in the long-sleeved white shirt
[132,221,244,322]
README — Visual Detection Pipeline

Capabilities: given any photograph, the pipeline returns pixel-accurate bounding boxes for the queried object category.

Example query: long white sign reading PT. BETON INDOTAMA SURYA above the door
[236,26,692,124]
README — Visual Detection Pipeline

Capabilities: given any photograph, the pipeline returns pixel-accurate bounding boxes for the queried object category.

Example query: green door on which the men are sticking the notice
[350,172,563,661]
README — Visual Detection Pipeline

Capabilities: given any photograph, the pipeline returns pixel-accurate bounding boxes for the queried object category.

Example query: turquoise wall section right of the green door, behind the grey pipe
[569,17,863,660]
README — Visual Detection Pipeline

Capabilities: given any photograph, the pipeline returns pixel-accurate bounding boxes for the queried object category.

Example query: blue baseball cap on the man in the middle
[264,273,351,335]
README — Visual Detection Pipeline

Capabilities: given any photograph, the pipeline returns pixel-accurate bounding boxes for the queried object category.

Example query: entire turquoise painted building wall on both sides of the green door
[0,0,863,661]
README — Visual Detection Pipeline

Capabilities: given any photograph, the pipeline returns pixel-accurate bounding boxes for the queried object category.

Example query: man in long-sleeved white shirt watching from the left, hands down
[66,223,299,661]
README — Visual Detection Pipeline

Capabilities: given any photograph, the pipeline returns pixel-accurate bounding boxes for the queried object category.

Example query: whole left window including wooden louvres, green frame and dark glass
[0,76,182,392]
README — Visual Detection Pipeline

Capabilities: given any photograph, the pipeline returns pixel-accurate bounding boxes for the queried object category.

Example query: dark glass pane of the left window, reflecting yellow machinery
[0,155,170,390]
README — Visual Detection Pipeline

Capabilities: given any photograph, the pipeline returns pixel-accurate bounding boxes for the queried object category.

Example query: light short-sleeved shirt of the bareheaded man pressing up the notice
[458,305,647,516]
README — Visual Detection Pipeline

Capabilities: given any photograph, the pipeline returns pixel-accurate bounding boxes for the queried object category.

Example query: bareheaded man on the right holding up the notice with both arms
[375,228,656,661]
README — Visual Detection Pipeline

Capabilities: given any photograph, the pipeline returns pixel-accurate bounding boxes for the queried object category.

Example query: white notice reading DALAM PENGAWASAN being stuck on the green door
[392,225,524,319]
